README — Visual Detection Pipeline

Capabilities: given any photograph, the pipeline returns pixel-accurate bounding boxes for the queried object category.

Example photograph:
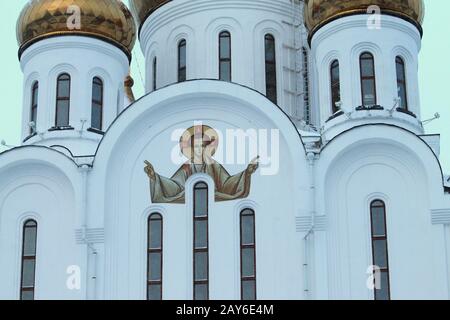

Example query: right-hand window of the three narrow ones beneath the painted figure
[241,209,256,300]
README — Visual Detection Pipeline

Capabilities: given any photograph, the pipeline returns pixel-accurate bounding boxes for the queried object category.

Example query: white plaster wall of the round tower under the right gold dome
[311,15,423,133]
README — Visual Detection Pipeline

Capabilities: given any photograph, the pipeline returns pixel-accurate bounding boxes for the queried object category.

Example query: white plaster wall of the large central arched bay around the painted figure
[92,81,307,299]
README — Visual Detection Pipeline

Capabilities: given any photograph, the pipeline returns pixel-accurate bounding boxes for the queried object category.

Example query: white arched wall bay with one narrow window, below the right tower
[318,125,445,299]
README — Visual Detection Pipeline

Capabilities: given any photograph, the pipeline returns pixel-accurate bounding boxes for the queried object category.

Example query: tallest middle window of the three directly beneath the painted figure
[194,182,209,300]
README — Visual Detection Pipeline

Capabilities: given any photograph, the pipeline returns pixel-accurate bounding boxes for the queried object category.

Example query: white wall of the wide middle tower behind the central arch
[140,0,303,116]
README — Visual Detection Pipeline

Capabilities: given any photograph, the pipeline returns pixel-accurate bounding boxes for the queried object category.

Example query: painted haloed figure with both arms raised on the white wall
[144,125,259,204]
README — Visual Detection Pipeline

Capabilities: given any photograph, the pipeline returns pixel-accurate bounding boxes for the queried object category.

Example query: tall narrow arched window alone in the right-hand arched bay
[370,200,390,300]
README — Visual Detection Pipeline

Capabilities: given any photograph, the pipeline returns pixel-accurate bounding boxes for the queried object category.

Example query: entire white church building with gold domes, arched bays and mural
[0,0,450,300]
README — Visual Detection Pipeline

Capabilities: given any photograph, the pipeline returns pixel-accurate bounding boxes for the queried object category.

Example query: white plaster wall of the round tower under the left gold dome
[20,36,129,155]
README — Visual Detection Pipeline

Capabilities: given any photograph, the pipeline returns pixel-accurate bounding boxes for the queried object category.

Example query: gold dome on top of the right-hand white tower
[305,0,425,34]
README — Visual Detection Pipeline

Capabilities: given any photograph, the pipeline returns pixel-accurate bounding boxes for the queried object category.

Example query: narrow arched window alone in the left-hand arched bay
[20,220,37,300]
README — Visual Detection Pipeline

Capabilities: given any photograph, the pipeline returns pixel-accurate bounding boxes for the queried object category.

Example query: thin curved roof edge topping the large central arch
[92,78,307,166]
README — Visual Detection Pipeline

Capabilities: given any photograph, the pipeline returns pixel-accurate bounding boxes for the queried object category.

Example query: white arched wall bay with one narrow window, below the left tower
[0,146,84,299]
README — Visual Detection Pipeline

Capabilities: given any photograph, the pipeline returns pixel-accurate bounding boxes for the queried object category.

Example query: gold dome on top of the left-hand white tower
[17,0,136,58]
